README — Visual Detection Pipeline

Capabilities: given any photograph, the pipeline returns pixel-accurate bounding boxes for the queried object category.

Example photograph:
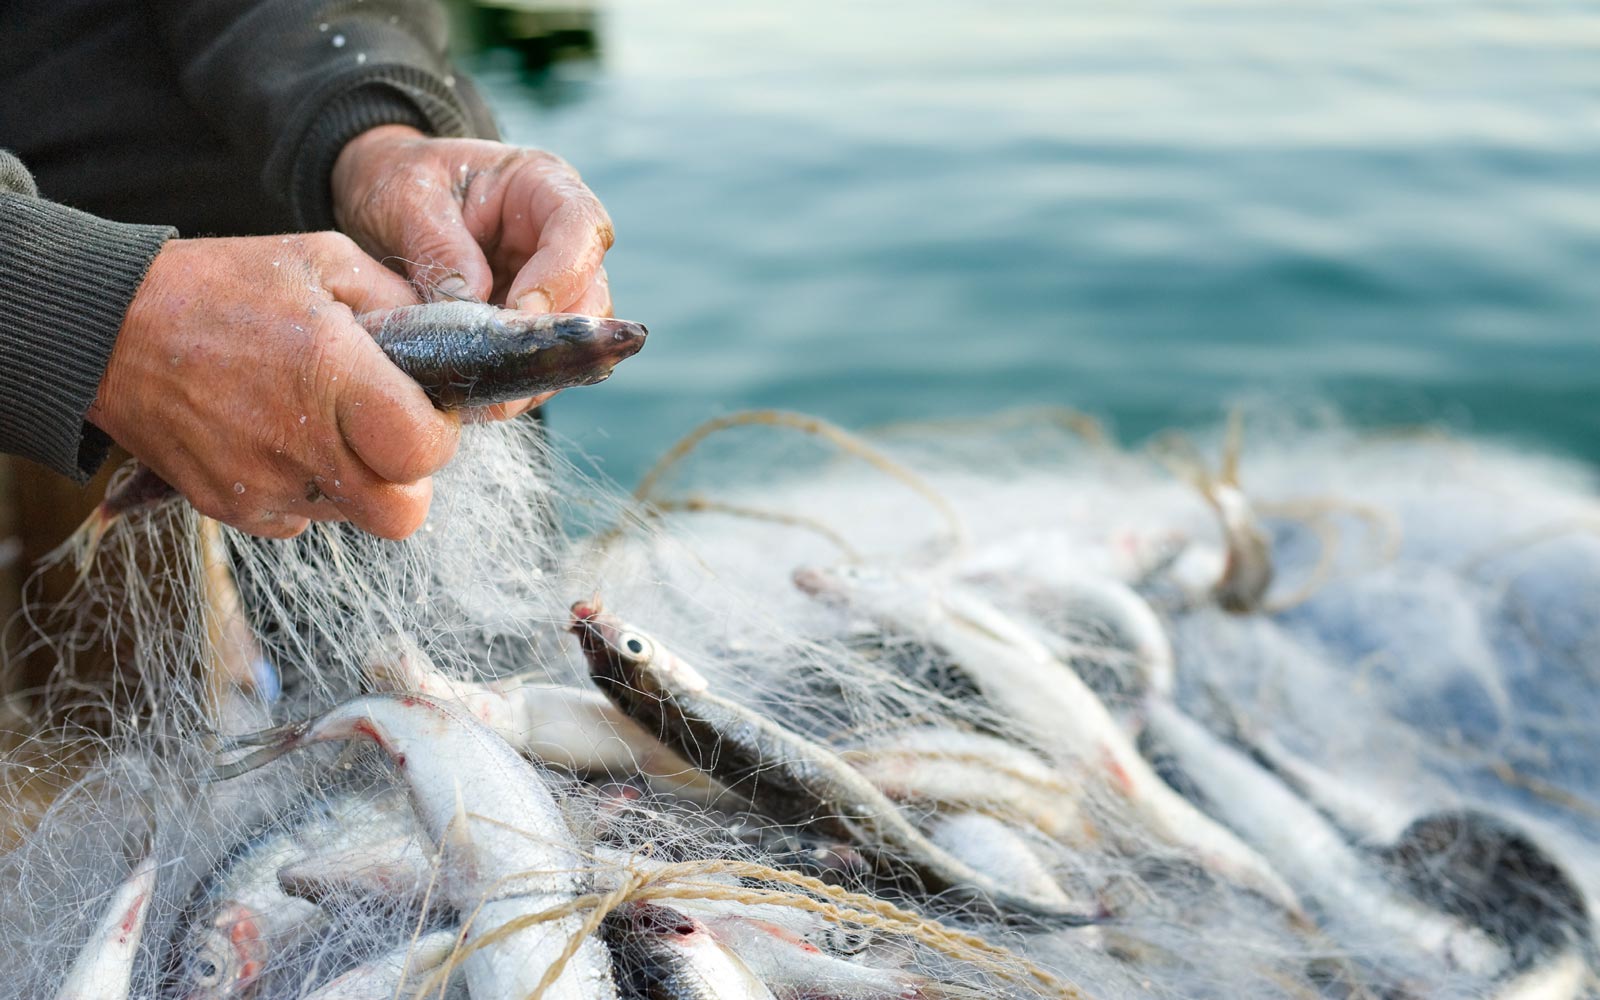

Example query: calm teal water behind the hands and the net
[475,0,1600,482]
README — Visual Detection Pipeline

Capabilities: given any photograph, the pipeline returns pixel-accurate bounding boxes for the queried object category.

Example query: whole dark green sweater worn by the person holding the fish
[0,0,494,482]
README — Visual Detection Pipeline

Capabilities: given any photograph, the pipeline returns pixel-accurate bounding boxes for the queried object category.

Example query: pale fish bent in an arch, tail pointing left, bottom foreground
[222,694,616,1000]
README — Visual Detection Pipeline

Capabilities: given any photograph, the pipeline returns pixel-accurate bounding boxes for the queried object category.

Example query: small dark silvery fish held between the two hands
[355,302,650,410]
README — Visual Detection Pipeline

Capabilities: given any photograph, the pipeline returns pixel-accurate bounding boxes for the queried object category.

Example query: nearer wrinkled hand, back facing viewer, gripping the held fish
[88,232,459,538]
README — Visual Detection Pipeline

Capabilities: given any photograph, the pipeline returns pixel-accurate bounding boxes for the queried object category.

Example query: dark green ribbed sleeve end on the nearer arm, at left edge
[0,150,176,482]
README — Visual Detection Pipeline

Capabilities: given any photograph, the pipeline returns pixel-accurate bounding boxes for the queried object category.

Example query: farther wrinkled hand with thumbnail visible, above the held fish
[333,125,613,418]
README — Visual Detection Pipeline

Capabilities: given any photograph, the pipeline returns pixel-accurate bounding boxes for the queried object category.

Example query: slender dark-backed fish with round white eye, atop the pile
[573,603,1099,926]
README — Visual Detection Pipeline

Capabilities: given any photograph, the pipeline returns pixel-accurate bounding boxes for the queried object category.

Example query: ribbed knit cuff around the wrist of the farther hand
[280,66,483,230]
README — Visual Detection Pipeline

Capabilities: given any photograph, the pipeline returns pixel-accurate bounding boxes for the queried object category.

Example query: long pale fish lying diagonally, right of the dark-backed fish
[795,566,1299,915]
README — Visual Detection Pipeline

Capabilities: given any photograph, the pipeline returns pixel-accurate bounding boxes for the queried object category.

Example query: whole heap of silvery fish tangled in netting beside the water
[12,400,1600,1000]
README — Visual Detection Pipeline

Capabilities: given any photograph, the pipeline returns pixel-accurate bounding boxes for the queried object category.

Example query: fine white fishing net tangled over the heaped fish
[0,411,1600,1000]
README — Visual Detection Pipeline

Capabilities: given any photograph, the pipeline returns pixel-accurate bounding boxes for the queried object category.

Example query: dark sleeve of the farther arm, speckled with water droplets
[150,0,494,229]
